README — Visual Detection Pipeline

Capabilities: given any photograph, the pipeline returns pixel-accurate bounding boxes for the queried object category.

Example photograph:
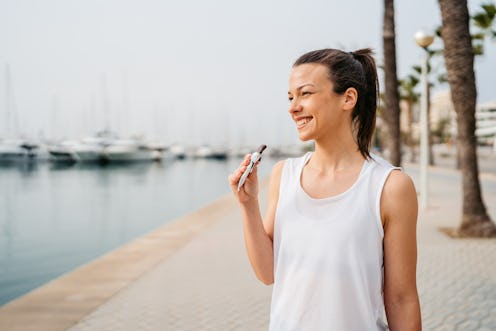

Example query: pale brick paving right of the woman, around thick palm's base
[413,169,496,331]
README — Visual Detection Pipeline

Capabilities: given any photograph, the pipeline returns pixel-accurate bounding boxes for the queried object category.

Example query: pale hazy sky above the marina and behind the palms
[0,0,496,145]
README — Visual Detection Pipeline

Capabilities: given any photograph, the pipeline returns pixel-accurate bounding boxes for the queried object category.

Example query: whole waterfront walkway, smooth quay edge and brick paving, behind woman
[0,163,496,331]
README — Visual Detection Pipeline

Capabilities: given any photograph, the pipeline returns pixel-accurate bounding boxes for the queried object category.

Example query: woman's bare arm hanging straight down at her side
[381,171,422,331]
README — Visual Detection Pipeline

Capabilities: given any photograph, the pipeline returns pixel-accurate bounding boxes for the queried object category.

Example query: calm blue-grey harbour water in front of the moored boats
[0,158,275,305]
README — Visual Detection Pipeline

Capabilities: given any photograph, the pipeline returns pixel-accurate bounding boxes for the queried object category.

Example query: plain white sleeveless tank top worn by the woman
[269,153,400,331]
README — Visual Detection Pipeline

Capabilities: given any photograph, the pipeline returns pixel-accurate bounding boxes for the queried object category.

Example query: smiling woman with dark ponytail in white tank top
[229,49,421,331]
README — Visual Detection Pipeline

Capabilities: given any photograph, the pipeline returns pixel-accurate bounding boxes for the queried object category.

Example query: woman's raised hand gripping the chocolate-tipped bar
[228,154,258,203]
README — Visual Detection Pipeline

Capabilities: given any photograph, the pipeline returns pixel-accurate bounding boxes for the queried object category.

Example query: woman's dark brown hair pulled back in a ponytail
[293,48,379,159]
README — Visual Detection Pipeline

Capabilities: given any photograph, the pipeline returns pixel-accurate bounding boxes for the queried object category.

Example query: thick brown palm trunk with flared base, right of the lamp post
[439,0,496,237]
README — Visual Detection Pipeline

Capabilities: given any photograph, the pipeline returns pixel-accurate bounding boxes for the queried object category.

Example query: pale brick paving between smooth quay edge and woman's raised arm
[70,189,271,331]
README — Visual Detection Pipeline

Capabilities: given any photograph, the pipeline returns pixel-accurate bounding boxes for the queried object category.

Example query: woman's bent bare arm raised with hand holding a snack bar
[229,156,283,285]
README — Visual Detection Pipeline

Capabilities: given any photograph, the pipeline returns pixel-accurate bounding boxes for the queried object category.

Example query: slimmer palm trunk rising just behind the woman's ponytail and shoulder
[382,0,401,166]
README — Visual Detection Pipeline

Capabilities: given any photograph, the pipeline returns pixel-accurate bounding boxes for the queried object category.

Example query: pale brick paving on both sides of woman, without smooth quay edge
[0,167,496,331]
